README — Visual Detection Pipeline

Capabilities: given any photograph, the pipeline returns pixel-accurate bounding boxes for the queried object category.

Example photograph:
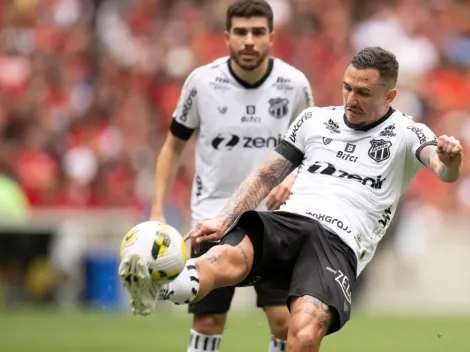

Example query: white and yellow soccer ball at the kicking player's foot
[120,221,188,283]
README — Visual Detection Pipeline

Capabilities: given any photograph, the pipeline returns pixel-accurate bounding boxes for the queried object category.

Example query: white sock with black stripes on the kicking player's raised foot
[158,259,199,304]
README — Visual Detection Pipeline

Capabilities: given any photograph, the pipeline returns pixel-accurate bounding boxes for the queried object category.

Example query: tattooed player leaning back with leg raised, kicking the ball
[124,47,463,352]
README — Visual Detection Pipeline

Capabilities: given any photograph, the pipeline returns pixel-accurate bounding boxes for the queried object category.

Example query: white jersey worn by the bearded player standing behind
[171,57,313,221]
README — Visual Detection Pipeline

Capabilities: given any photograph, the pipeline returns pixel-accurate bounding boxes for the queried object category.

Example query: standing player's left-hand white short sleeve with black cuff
[170,71,200,140]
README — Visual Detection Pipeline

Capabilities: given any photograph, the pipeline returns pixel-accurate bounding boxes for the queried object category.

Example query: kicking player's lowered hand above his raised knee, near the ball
[183,217,229,253]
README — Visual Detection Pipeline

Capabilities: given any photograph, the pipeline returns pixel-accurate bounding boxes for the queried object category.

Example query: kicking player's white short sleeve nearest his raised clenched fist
[406,123,437,170]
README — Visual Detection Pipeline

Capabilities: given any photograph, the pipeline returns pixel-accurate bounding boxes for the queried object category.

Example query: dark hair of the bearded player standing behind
[225,0,273,32]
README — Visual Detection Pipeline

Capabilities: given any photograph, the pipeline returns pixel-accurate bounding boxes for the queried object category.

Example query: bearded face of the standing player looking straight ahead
[225,17,273,71]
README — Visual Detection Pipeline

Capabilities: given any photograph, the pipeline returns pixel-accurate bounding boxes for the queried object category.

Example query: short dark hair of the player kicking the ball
[351,46,399,88]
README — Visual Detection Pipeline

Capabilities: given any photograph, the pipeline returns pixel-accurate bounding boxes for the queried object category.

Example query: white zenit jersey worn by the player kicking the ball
[279,107,437,275]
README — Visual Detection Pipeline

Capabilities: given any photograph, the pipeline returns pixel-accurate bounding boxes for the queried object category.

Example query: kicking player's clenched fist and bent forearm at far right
[419,136,463,183]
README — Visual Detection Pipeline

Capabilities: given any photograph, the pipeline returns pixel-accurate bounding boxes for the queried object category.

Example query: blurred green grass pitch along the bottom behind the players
[0,310,470,352]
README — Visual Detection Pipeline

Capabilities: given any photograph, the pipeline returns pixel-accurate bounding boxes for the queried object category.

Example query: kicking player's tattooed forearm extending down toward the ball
[220,152,296,223]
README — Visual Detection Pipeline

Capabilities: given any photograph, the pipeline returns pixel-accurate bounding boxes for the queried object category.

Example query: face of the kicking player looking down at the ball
[343,65,397,126]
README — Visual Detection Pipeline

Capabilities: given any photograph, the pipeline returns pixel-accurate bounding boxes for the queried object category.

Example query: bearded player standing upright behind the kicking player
[121,0,313,352]
